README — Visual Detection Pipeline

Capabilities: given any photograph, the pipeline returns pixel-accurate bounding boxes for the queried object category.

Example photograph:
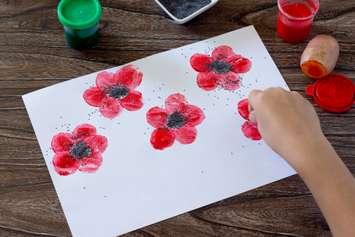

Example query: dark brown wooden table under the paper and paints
[0,0,355,237]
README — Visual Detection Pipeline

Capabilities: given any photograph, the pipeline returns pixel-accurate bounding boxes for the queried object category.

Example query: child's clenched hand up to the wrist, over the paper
[249,88,326,169]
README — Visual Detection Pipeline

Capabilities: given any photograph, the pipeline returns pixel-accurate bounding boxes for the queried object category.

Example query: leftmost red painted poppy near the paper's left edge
[51,124,107,176]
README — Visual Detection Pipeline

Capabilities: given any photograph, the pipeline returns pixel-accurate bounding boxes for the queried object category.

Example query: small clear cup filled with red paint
[277,0,319,43]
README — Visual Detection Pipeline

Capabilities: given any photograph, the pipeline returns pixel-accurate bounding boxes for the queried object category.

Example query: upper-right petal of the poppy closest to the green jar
[114,65,143,90]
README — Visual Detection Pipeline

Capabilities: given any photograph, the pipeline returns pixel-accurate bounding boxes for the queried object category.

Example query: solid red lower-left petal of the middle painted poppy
[150,128,175,150]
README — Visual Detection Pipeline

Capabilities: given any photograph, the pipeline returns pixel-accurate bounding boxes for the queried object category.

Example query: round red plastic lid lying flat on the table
[306,74,355,113]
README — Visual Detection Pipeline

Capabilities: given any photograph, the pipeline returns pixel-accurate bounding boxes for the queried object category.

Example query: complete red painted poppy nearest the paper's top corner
[190,45,252,91]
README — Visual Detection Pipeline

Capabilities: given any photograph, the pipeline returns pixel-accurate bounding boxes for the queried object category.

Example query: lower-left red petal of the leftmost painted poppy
[53,152,79,176]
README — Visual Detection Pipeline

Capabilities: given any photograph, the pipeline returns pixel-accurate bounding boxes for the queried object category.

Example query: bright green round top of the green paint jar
[57,0,102,30]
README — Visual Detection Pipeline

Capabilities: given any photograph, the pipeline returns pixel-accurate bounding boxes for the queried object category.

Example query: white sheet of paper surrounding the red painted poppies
[23,26,295,237]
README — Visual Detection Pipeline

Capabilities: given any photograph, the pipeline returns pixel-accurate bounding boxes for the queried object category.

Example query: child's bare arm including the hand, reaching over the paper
[249,88,355,237]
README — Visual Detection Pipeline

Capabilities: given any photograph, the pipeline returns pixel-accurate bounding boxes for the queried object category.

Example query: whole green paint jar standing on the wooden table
[57,0,102,49]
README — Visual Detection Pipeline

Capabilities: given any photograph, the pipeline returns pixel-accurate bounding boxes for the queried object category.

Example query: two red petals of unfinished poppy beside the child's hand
[237,99,261,140]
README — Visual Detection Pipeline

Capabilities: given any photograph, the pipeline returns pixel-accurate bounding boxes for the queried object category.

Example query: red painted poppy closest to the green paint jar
[83,65,143,119]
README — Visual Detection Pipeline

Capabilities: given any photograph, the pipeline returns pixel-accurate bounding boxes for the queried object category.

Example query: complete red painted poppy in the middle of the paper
[147,93,205,150]
